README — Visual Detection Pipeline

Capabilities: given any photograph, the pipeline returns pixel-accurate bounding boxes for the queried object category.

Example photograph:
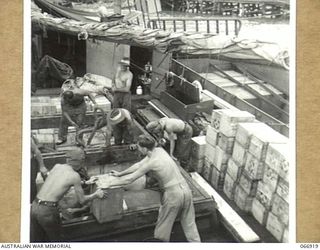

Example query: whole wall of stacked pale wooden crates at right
[189,109,289,242]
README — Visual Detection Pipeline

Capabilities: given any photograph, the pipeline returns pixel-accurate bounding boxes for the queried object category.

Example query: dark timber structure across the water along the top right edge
[161,0,289,18]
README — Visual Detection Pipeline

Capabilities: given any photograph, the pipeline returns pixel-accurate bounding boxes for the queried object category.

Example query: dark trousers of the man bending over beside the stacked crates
[173,123,193,167]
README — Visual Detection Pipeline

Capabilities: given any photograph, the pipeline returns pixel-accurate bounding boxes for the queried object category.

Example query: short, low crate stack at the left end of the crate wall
[188,136,206,173]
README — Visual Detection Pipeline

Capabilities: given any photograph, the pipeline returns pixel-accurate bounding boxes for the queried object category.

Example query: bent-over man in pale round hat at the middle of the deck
[108,108,134,145]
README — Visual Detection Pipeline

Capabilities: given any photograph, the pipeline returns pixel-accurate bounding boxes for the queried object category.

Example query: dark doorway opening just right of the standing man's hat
[130,46,152,94]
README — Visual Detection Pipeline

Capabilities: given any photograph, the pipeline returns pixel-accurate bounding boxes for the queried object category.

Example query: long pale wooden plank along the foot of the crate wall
[191,173,260,243]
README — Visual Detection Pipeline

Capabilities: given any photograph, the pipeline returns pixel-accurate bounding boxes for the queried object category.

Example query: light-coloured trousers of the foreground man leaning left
[154,183,200,242]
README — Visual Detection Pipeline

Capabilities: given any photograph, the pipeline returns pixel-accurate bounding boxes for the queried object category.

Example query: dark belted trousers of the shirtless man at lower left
[30,201,62,242]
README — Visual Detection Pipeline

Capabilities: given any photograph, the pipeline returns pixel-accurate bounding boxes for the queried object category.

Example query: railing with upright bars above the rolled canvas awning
[147,18,241,36]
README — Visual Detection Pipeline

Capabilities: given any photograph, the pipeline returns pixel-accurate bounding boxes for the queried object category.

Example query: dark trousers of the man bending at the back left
[58,102,87,140]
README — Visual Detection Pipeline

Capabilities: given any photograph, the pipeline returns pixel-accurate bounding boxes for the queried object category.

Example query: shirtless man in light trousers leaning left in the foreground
[107,135,200,242]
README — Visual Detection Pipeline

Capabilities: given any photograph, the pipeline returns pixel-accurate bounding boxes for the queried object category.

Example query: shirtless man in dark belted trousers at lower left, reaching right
[30,148,106,242]
